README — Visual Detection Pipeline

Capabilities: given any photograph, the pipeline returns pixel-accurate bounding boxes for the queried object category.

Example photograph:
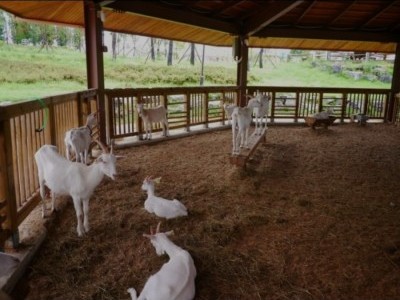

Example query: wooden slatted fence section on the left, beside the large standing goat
[0,90,97,248]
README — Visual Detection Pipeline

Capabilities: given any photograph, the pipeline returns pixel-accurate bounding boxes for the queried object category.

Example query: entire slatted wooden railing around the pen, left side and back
[0,86,400,248]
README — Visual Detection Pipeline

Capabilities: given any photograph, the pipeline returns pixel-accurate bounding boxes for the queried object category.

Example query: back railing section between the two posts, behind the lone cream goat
[105,87,238,139]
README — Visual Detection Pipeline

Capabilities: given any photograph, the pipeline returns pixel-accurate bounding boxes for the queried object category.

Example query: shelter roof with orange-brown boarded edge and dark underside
[0,0,400,53]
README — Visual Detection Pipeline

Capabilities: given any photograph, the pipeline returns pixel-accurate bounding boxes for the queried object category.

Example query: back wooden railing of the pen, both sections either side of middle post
[105,86,391,144]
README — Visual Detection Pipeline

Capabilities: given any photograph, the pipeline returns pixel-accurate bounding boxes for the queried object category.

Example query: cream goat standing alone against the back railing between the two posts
[136,103,169,140]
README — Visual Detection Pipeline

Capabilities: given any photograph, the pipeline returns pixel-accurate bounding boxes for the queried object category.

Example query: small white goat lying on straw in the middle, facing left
[142,176,188,219]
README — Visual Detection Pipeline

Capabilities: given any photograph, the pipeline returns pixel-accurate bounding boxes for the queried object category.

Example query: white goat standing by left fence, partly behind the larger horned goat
[64,113,97,164]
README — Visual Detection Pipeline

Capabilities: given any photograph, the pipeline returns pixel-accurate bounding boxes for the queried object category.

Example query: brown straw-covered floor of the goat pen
[20,124,400,300]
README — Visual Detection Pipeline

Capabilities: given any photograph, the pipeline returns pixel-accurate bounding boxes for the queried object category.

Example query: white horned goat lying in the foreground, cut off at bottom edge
[128,223,197,300]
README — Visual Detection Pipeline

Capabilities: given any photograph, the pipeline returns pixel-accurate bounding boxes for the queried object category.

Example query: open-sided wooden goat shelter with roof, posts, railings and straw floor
[0,0,400,299]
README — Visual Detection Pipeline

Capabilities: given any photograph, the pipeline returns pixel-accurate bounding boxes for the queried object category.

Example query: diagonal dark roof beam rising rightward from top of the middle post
[243,0,304,36]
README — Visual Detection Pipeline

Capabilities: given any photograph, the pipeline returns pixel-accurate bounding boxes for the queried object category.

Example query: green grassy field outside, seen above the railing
[0,42,393,102]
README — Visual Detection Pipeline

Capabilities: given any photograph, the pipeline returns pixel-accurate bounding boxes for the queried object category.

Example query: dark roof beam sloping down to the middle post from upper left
[106,0,239,34]
